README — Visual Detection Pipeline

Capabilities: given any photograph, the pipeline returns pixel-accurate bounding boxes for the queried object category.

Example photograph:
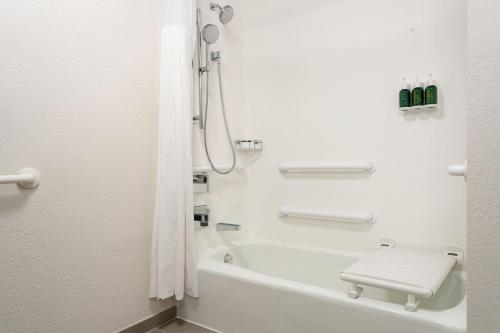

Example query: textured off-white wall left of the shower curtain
[0,0,175,333]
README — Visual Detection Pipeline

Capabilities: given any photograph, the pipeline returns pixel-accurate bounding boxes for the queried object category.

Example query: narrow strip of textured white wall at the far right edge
[467,0,500,333]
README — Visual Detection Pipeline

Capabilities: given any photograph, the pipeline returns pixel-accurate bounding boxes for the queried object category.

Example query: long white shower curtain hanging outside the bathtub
[150,0,198,300]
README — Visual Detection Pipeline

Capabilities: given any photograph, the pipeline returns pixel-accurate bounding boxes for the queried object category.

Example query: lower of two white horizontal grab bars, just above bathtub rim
[278,207,377,224]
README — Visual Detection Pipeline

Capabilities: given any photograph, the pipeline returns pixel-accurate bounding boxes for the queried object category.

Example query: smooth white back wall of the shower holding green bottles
[237,0,466,251]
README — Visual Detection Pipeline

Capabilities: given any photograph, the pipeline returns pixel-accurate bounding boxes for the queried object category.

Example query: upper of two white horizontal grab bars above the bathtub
[279,161,375,173]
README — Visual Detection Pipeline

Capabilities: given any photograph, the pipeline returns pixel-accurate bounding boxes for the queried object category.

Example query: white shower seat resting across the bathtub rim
[340,247,461,311]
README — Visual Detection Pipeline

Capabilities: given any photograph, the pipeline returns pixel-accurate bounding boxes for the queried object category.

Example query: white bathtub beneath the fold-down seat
[179,241,466,333]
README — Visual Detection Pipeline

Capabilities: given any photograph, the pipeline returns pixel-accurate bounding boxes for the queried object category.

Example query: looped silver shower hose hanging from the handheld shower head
[203,60,236,175]
